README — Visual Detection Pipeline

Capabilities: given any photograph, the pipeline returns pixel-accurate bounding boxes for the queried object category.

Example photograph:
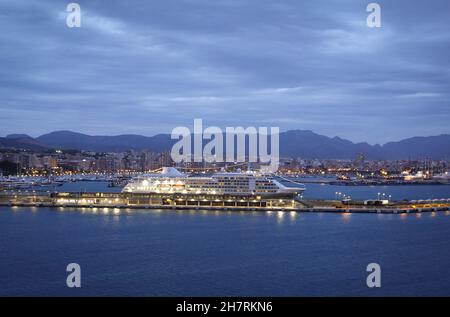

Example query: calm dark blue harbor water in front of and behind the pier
[0,182,450,296]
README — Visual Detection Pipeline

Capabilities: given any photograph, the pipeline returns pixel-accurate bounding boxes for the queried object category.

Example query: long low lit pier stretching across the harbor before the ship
[0,191,450,214]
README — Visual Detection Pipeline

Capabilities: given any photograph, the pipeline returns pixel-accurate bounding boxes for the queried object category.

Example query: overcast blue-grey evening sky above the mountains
[0,0,450,143]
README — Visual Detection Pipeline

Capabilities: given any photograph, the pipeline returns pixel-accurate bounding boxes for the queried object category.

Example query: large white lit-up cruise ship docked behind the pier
[122,167,305,199]
